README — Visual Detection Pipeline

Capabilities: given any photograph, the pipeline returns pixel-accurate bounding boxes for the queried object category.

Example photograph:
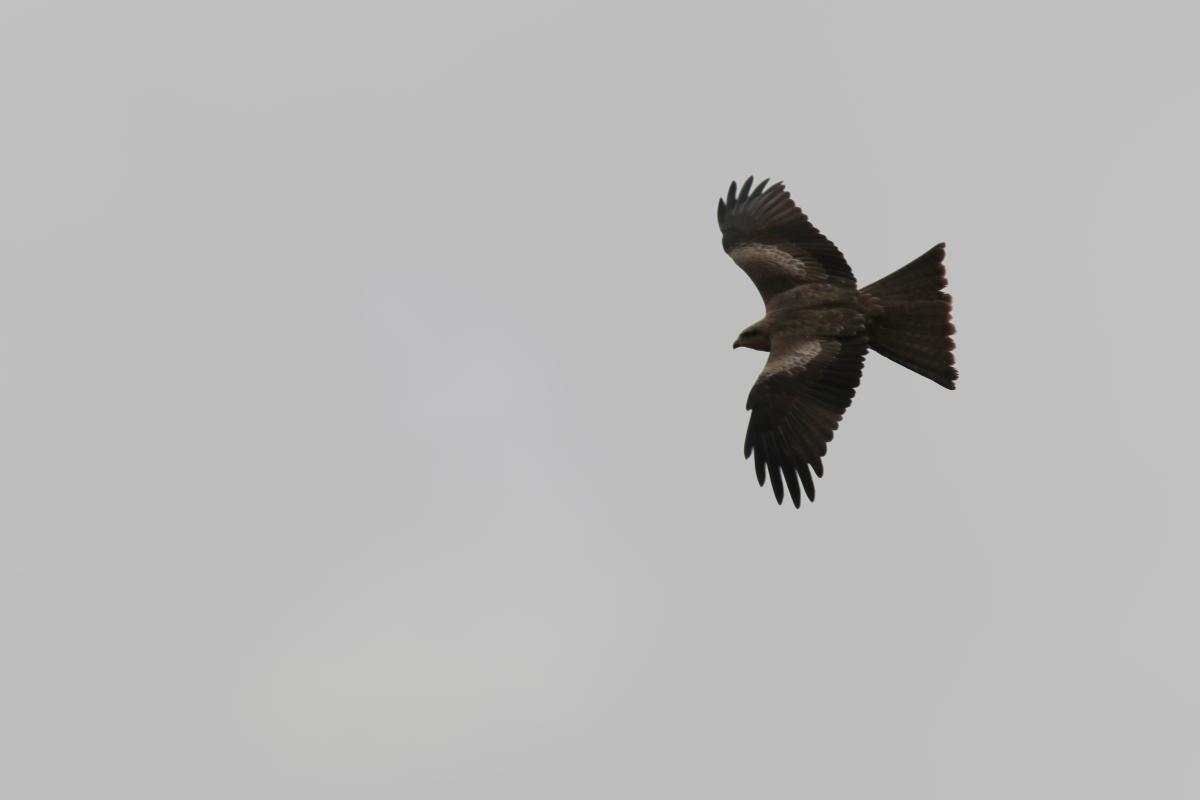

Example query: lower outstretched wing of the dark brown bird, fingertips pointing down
[745,335,868,509]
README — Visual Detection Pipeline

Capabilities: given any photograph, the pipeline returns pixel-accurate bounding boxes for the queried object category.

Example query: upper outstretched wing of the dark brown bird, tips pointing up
[716,176,856,306]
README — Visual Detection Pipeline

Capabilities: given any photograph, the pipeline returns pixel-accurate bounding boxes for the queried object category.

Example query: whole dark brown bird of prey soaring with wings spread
[716,178,959,509]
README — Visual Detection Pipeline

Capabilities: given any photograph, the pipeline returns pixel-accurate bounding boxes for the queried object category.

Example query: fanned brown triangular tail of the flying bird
[862,245,959,389]
